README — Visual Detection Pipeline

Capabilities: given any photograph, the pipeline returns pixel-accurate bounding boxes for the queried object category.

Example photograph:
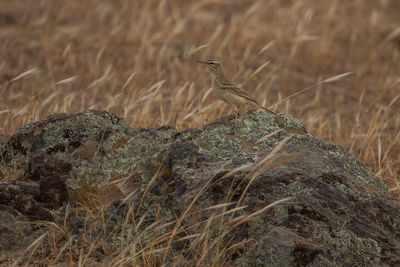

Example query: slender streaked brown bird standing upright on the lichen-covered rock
[197,59,276,132]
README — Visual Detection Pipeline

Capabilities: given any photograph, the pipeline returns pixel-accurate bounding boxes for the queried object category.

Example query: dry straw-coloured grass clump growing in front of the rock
[4,133,292,266]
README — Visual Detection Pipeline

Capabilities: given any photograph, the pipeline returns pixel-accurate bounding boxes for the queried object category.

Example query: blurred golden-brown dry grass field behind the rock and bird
[0,0,400,266]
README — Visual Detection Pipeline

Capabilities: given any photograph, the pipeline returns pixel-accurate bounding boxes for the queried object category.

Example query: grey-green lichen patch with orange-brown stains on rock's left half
[56,113,179,193]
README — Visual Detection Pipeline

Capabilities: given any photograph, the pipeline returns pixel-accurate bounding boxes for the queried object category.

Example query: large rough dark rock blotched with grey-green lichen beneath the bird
[0,111,400,266]
